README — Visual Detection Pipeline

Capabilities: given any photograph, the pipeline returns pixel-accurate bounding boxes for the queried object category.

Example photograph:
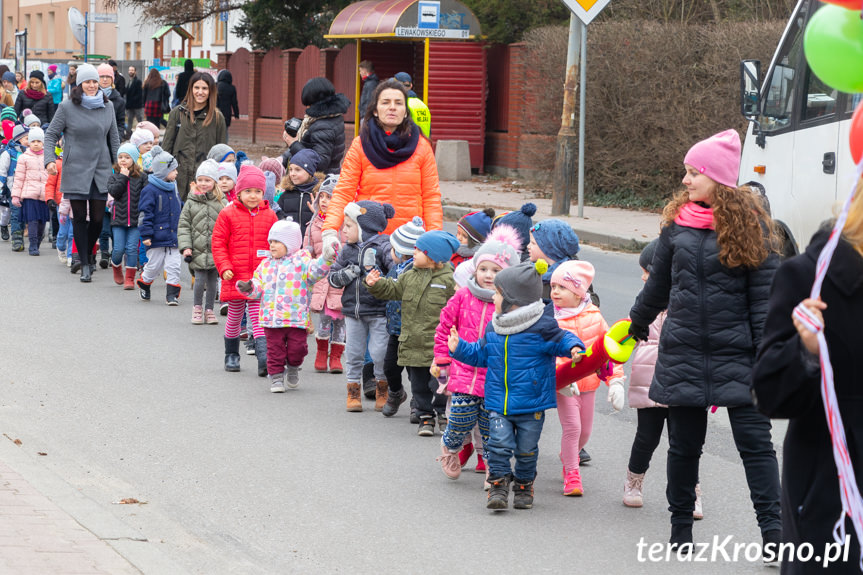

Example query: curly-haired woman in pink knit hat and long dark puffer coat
[630,130,781,557]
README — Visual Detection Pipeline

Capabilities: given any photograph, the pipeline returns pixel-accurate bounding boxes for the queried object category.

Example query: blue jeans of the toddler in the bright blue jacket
[486,411,548,484]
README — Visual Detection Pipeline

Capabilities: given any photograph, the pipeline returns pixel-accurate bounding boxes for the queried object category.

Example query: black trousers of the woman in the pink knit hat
[665,405,782,534]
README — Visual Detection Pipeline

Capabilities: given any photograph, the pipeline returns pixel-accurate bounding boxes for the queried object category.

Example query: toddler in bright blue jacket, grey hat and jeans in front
[448,260,585,511]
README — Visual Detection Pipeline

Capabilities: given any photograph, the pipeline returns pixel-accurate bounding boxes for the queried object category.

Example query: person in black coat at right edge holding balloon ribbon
[752,194,863,574]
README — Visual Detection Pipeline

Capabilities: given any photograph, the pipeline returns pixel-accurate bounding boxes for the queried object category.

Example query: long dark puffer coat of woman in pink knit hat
[629,218,779,407]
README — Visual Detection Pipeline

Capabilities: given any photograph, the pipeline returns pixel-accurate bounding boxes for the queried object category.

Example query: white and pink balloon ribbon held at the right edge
[810,161,863,571]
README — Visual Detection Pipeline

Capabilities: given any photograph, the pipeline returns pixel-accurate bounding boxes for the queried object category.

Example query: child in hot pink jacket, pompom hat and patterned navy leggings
[432,225,521,479]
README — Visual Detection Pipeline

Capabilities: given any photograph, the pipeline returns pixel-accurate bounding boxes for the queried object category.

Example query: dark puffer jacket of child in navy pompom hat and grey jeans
[327,235,392,319]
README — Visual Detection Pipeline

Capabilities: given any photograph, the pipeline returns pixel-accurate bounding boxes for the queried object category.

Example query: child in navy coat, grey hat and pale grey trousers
[138,146,181,306]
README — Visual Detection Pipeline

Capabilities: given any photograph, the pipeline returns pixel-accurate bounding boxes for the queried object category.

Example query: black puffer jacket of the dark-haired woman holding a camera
[290,94,351,174]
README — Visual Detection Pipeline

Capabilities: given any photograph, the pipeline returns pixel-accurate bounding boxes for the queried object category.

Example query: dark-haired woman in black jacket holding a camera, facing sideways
[282,78,351,174]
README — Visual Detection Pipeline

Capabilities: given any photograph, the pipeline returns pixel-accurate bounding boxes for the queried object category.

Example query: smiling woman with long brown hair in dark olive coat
[162,72,228,202]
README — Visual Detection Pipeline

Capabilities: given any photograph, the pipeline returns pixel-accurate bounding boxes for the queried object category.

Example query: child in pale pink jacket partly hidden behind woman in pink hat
[623,240,704,519]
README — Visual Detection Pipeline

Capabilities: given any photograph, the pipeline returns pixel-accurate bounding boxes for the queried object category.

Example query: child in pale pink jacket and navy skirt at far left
[12,128,51,256]
